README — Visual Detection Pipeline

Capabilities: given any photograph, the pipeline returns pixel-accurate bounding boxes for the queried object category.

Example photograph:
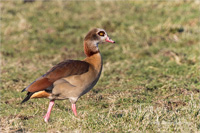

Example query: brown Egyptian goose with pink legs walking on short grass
[22,28,115,122]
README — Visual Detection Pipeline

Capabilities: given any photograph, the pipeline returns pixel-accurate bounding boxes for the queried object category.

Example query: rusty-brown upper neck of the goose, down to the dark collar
[84,41,100,57]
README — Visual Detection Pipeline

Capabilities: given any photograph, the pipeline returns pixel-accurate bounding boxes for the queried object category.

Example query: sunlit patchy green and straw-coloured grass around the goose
[0,1,200,132]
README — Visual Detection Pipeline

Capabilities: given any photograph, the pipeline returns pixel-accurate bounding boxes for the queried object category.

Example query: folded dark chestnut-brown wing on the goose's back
[22,60,89,92]
